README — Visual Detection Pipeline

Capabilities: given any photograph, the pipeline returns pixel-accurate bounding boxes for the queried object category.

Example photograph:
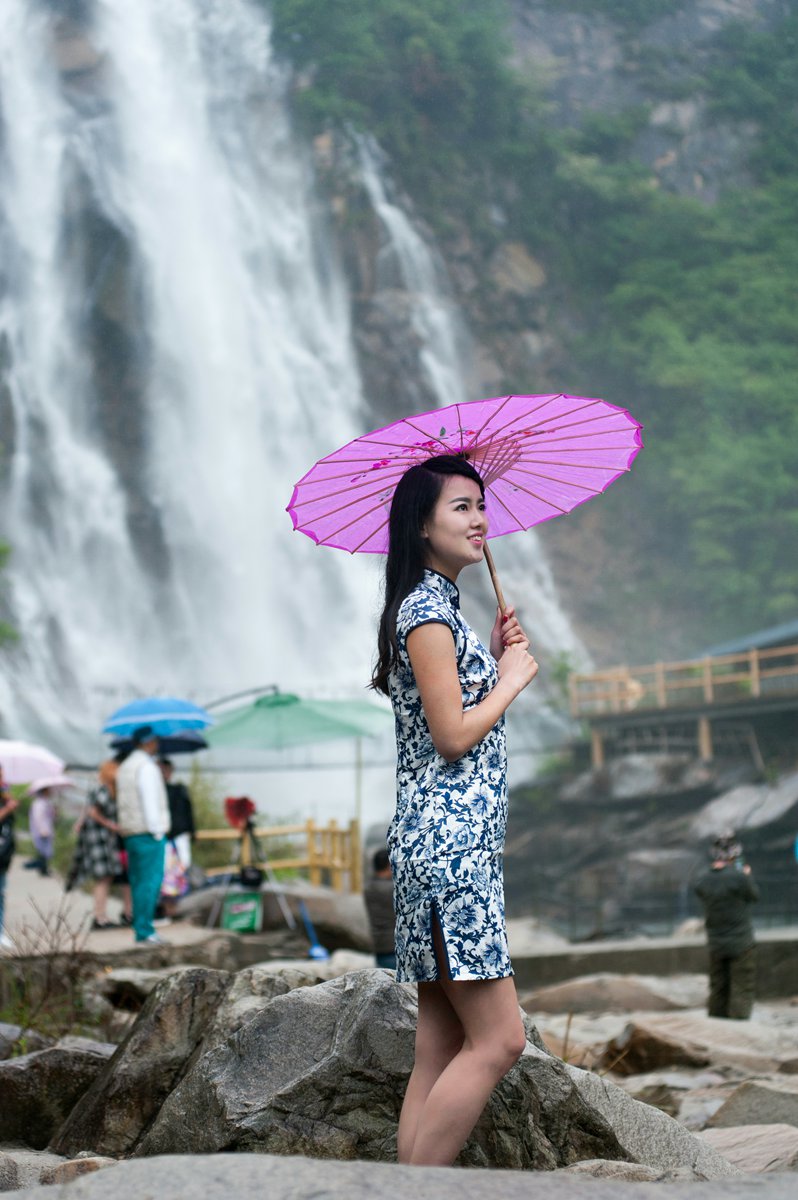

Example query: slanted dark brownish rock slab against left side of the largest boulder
[49,967,230,1158]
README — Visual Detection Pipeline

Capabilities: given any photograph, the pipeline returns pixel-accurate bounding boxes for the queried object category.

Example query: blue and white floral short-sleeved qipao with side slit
[388,570,512,983]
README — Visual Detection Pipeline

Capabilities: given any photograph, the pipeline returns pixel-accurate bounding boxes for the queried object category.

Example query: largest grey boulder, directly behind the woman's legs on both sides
[133,970,626,1169]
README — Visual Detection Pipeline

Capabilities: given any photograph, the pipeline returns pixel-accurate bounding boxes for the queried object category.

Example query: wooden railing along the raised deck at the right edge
[569,646,798,718]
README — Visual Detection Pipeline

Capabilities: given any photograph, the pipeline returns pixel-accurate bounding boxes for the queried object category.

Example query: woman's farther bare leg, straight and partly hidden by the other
[396,983,463,1163]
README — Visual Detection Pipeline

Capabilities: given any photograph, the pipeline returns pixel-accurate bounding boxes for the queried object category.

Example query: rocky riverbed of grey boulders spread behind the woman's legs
[0,954,798,1200]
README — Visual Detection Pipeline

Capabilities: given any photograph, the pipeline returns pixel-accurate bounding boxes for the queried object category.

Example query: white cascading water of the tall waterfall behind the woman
[0,0,585,803]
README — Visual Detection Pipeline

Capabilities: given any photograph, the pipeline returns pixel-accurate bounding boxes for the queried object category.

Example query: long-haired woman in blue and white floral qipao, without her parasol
[373,455,538,1165]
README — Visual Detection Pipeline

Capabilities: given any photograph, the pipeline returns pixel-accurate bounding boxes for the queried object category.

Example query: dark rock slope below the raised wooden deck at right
[505,754,798,940]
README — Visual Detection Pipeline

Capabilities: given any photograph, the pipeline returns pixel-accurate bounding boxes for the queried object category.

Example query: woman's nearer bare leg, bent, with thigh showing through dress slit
[408,922,526,1166]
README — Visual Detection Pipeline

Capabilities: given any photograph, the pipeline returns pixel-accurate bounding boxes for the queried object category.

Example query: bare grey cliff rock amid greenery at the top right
[512,0,791,203]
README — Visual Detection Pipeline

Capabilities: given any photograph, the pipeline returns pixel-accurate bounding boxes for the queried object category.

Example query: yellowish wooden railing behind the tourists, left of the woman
[194,821,362,892]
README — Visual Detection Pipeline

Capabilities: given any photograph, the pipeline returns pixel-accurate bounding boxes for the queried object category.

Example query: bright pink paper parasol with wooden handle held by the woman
[287,392,643,608]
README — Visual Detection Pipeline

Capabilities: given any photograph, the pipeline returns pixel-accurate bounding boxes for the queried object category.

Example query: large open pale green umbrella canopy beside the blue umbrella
[204,691,392,750]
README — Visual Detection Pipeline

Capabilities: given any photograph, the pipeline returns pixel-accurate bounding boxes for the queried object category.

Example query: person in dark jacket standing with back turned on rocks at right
[696,834,760,1021]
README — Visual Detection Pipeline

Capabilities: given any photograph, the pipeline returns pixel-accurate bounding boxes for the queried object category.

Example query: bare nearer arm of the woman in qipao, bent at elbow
[407,623,538,762]
